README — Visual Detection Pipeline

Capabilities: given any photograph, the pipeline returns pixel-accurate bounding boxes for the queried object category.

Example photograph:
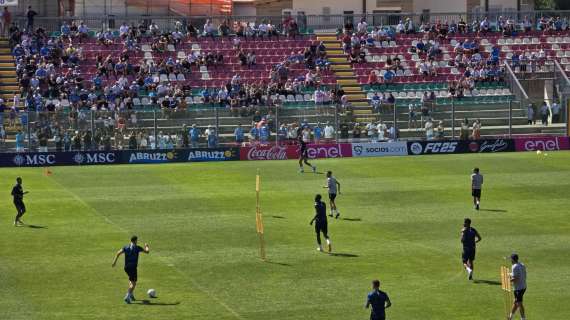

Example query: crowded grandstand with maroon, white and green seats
[0,1,570,151]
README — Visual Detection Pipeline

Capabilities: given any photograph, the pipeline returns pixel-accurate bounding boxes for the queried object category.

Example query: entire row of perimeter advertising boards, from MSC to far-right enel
[0,136,570,167]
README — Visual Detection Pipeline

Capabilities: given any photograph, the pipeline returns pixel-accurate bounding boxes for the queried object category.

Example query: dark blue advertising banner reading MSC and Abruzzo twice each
[0,148,239,167]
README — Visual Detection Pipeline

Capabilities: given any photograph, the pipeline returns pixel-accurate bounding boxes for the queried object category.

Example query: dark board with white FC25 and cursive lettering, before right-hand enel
[408,138,515,155]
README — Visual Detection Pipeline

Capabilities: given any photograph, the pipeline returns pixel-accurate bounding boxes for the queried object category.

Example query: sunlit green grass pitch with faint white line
[0,152,570,320]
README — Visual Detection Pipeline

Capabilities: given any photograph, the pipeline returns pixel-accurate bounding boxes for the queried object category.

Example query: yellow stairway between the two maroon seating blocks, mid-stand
[317,33,375,122]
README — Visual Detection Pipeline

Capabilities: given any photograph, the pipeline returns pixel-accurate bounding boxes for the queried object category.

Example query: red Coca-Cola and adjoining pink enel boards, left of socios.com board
[239,143,352,160]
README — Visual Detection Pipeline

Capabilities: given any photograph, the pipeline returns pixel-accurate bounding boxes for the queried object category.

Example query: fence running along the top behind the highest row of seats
[10,10,570,32]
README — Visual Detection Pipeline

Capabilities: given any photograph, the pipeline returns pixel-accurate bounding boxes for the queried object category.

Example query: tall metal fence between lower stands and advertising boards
[0,100,566,152]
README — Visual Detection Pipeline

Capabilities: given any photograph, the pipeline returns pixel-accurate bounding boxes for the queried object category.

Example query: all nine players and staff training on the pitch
[12,162,526,320]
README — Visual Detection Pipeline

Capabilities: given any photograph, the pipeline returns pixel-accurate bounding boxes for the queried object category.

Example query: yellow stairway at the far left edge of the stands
[0,38,20,106]
